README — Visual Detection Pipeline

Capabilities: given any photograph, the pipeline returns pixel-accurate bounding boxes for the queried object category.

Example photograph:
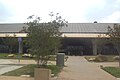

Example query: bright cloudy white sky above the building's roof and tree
[0,0,120,23]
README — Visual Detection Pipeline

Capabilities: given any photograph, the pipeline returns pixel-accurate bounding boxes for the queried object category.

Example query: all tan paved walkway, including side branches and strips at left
[0,56,118,80]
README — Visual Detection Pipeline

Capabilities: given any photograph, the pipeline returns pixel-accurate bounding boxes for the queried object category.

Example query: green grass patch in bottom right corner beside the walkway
[102,67,120,78]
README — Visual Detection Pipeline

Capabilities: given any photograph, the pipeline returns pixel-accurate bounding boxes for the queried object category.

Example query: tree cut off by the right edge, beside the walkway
[107,24,120,67]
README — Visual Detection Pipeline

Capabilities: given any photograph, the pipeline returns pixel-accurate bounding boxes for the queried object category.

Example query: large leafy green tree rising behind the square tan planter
[27,15,66,67]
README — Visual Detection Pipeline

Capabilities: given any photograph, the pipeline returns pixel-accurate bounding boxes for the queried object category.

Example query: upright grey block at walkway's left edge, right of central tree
[56,53,65,67]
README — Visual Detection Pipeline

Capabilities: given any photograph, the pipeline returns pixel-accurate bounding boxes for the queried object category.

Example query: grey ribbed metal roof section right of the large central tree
[61,23,119,33]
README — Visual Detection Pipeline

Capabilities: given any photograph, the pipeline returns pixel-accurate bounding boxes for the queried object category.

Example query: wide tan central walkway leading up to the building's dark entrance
[57,56,117,80]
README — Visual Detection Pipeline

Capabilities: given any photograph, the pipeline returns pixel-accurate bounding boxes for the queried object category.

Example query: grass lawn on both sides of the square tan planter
[3,64,61,77]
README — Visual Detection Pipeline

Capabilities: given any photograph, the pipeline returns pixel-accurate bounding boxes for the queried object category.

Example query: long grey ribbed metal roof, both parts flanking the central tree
[0,23,118,33]
